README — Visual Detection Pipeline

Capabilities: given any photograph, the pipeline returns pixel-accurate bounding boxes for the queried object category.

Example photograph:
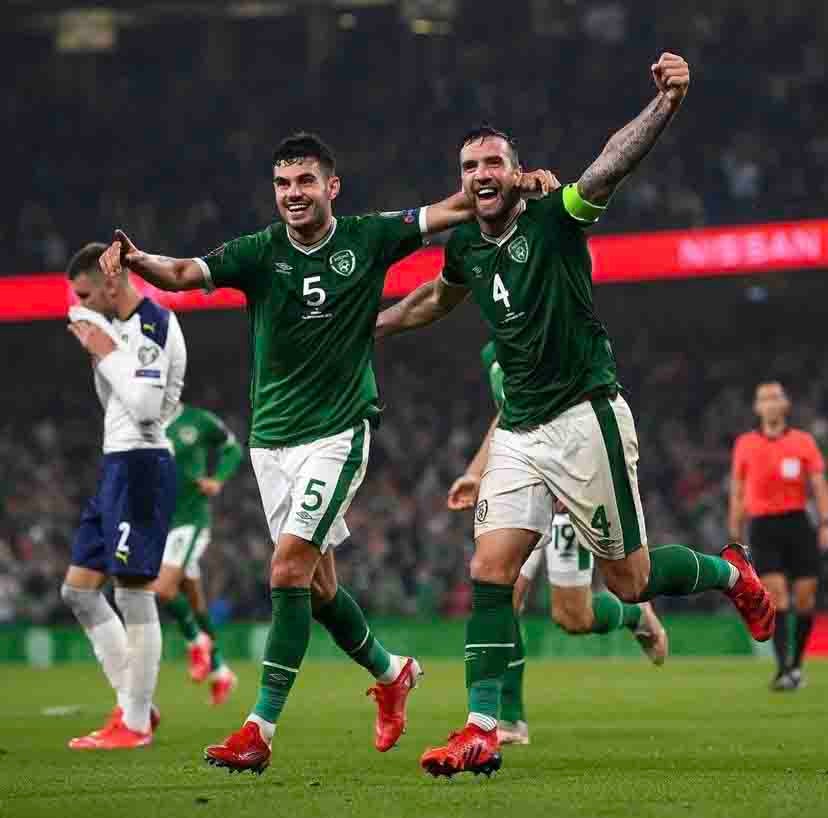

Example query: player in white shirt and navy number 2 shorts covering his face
[61,243,187,750]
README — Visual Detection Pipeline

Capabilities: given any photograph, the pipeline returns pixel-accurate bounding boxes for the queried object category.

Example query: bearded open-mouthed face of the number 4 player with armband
[460,136,520,222]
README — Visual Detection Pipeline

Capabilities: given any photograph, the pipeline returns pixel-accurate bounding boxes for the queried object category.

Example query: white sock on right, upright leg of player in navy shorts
[115,588,161,733]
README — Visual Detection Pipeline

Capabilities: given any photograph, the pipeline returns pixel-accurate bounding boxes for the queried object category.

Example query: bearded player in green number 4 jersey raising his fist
[377,54,774,775]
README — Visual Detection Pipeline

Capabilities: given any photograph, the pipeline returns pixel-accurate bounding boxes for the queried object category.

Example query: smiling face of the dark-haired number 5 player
[273,157,340,234]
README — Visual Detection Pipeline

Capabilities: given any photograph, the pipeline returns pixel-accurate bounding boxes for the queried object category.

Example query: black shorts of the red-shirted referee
[750,511,820,580]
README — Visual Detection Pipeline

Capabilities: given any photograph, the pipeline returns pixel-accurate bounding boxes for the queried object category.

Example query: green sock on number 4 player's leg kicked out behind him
[641,545,733,601]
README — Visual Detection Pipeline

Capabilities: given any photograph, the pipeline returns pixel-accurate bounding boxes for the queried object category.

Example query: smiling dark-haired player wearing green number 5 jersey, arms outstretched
[103,129,548,773]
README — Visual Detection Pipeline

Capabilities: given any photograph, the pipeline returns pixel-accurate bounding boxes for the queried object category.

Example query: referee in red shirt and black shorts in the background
[728,381,828,690]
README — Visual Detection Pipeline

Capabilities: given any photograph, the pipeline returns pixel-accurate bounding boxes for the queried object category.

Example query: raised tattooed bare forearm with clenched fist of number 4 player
[578,53,690,205]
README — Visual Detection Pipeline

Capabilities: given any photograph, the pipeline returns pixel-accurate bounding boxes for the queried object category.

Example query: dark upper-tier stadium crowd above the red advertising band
[6,0,828,274]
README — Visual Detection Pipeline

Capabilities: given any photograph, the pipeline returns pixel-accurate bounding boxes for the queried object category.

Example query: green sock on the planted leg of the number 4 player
[465,580,517,719]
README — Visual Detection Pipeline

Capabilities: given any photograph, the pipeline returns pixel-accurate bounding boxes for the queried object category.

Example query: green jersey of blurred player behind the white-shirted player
[166,403,242,528]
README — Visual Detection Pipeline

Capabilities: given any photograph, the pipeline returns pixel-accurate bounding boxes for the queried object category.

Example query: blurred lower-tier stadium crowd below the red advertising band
[0,292,828,622]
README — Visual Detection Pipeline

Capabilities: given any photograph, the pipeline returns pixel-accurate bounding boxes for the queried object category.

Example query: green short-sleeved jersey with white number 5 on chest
[204,210,423,448]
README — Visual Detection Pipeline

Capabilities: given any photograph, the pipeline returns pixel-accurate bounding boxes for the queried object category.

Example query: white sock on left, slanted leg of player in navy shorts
[60,584,129,708]
